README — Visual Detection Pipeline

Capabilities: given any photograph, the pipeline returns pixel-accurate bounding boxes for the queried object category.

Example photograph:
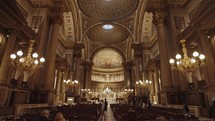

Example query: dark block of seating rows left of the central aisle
[1,104,101,121]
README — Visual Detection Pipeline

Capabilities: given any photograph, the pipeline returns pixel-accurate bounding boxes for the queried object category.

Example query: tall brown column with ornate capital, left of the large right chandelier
[153,11,173,105]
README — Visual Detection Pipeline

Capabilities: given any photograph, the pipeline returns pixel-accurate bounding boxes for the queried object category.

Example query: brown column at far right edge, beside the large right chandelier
[199,31,215,103]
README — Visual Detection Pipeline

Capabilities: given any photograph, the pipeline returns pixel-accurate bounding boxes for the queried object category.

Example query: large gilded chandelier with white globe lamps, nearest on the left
[10,40,45,72]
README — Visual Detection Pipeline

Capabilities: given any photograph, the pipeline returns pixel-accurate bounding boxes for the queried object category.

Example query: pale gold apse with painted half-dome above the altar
[92,48,124,82]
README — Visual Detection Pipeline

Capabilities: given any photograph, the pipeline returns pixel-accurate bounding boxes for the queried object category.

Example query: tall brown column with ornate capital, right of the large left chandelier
[43,4,63,105]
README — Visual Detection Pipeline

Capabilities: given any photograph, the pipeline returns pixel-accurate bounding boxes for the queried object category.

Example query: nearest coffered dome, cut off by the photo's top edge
[78,0,139,22]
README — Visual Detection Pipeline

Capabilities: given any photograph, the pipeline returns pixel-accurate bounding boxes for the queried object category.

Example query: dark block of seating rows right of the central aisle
[110,104,198,121]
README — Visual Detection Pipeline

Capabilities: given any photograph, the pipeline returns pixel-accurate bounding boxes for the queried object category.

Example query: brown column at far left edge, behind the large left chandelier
[0,30,17,84]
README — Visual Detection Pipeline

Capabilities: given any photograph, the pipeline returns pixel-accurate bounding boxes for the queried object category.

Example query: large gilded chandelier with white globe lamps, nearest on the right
[169,40,205,72]
